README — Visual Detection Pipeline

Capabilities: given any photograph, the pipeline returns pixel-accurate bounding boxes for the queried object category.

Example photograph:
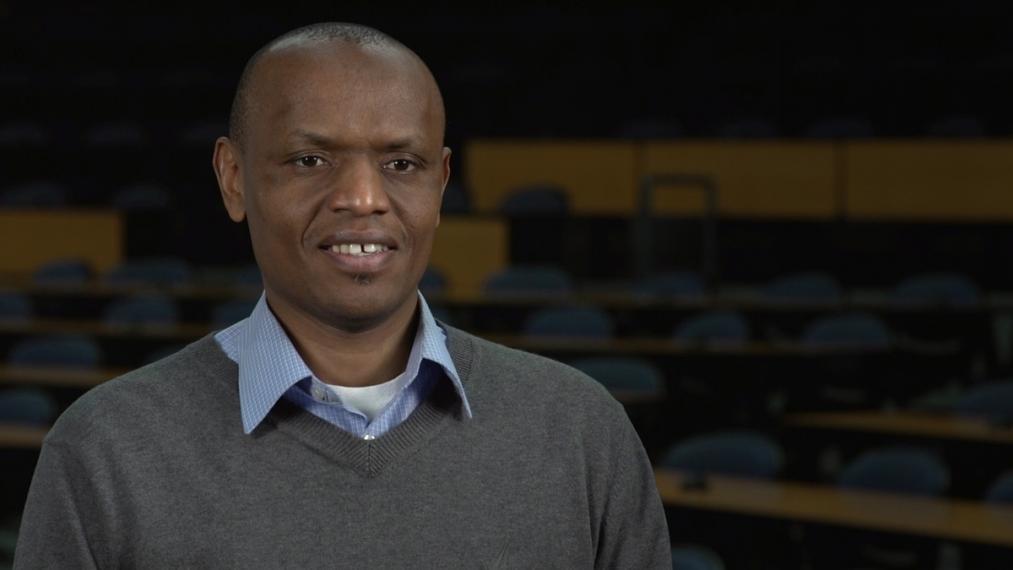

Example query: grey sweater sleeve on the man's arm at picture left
[14,442,99,570]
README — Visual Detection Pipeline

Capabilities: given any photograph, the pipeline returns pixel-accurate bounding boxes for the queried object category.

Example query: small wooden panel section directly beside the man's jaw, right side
[430,216,510,295]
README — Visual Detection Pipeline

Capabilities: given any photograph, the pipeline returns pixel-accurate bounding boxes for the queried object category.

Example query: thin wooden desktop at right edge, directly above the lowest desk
[785,411,1013,444]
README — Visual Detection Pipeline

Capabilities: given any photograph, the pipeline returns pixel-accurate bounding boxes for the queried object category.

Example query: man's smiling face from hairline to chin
[216,44,450,330]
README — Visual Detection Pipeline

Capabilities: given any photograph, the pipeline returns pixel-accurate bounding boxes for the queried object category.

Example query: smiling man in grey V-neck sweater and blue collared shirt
[15,23,671,568]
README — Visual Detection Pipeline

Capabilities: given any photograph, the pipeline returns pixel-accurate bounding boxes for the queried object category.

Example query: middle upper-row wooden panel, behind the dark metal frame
[643,141,838,218]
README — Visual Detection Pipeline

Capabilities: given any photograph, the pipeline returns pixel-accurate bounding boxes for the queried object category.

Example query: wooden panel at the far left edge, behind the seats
[0,211,124,273]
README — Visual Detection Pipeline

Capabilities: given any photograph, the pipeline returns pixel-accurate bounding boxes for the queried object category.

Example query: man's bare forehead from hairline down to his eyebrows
[248,42,443,144]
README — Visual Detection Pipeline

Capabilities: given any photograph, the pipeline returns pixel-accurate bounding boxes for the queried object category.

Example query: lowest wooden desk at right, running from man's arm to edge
[654,470,1013,547]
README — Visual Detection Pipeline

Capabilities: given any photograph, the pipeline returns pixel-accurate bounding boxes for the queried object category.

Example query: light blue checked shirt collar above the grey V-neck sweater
[215,293,471,439]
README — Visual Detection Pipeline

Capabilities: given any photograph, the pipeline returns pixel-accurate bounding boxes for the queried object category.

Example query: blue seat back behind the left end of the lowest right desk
[660,431,784,479]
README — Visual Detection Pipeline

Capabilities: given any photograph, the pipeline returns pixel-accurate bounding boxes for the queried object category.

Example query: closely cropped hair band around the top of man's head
[229,22,446,145]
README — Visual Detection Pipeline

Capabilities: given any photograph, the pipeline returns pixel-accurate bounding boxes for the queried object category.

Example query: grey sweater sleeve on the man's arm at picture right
[595,413,672,569]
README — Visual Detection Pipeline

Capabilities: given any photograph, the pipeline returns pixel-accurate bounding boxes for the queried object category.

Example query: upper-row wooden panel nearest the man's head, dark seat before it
[464,141,637,215]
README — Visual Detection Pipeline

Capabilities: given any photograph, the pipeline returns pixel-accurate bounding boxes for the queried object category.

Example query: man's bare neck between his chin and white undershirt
[267,298,418,387]
